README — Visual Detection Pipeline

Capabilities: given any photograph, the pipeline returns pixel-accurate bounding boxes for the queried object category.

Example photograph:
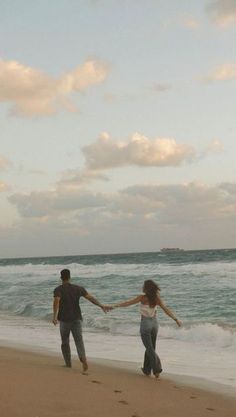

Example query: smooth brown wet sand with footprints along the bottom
[0,347,236,417]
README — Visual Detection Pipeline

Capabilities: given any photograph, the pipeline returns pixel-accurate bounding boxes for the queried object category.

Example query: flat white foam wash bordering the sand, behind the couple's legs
[0,315,236,387]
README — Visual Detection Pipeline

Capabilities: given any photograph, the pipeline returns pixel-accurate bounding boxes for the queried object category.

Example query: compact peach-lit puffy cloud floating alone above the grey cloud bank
[82,132,195,170]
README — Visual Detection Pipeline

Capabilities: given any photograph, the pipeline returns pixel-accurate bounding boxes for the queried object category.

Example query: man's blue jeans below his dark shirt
[60,320,86,367]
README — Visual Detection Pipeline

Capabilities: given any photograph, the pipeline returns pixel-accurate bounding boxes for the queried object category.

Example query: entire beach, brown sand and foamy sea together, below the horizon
[0,250,236,417]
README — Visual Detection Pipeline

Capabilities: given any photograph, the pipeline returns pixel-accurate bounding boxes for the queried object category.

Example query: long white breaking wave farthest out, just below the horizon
[0,261,236,281]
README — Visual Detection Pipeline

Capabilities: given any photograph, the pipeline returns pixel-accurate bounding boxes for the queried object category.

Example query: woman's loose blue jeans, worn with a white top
[140,316,162,375]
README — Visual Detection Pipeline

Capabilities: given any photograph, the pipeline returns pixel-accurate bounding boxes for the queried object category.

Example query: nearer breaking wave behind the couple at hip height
[1,302,236,352]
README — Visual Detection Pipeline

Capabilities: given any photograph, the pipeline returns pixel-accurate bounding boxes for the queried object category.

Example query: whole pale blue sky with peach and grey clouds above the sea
[0,0,236,258]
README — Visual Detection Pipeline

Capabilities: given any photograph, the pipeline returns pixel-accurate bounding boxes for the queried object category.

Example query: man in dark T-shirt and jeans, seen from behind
[52,269,108,373]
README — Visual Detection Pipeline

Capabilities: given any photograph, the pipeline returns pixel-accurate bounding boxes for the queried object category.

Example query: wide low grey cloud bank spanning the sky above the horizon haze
[9,182,236,223]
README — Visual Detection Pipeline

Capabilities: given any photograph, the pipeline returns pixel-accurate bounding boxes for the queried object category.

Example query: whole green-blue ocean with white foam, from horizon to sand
[0,249,236,387]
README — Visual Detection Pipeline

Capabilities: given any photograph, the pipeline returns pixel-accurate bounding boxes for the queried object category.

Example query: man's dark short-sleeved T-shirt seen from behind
[54,282,88,321]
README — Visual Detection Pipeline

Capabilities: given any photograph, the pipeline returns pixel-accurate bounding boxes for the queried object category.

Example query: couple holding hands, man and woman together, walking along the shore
[52,269,182,378]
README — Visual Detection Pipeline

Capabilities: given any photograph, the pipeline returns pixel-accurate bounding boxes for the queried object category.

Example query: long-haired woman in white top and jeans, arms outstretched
[111,279,181,378]
